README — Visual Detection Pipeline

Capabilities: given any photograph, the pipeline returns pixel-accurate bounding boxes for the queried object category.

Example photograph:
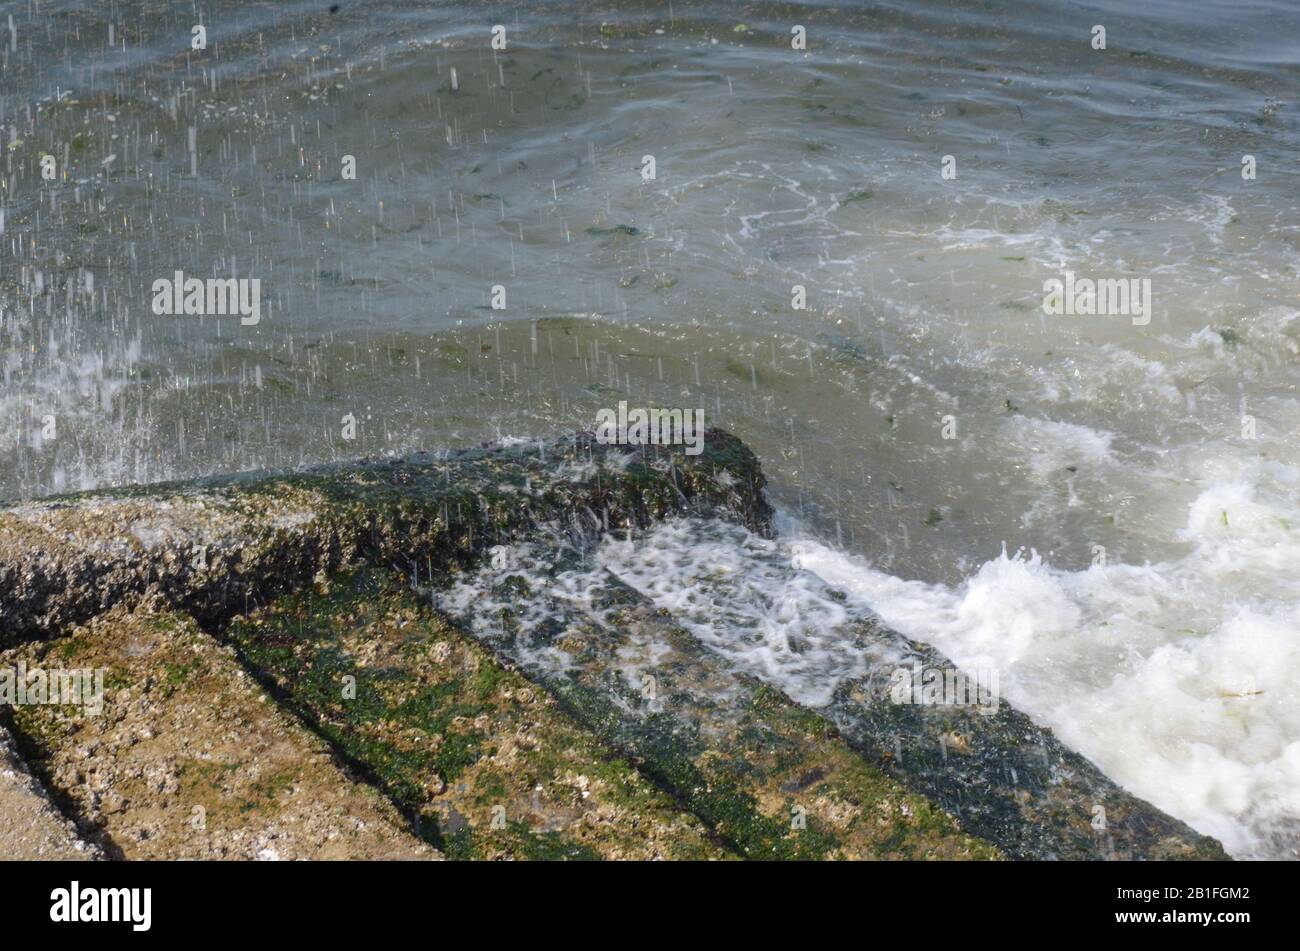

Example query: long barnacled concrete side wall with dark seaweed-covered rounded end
[0,430,771,646]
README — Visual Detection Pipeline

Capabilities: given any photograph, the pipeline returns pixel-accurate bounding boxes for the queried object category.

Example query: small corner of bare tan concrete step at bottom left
[0,725,103,861]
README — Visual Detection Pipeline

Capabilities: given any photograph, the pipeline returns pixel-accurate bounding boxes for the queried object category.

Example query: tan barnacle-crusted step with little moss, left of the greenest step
[0,607,439,859]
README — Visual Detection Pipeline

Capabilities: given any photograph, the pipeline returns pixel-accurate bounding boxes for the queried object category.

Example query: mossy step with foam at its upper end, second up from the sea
[426,535,1001,859]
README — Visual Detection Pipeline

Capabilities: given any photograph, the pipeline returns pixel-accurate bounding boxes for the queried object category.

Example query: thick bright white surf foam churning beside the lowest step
[796,485,1300,857]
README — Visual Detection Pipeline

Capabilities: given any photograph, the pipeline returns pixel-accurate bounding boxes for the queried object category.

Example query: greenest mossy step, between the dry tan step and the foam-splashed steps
[225,569,737,860]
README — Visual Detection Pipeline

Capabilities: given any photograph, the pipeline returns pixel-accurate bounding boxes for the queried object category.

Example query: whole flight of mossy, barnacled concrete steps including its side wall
[0,430,1223,859]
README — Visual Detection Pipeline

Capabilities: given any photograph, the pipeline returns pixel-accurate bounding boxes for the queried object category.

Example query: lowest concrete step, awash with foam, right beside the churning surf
[593,518,1227,860]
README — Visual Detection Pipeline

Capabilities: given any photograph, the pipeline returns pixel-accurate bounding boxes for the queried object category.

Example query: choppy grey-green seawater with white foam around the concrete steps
[0,0,1300,856]
